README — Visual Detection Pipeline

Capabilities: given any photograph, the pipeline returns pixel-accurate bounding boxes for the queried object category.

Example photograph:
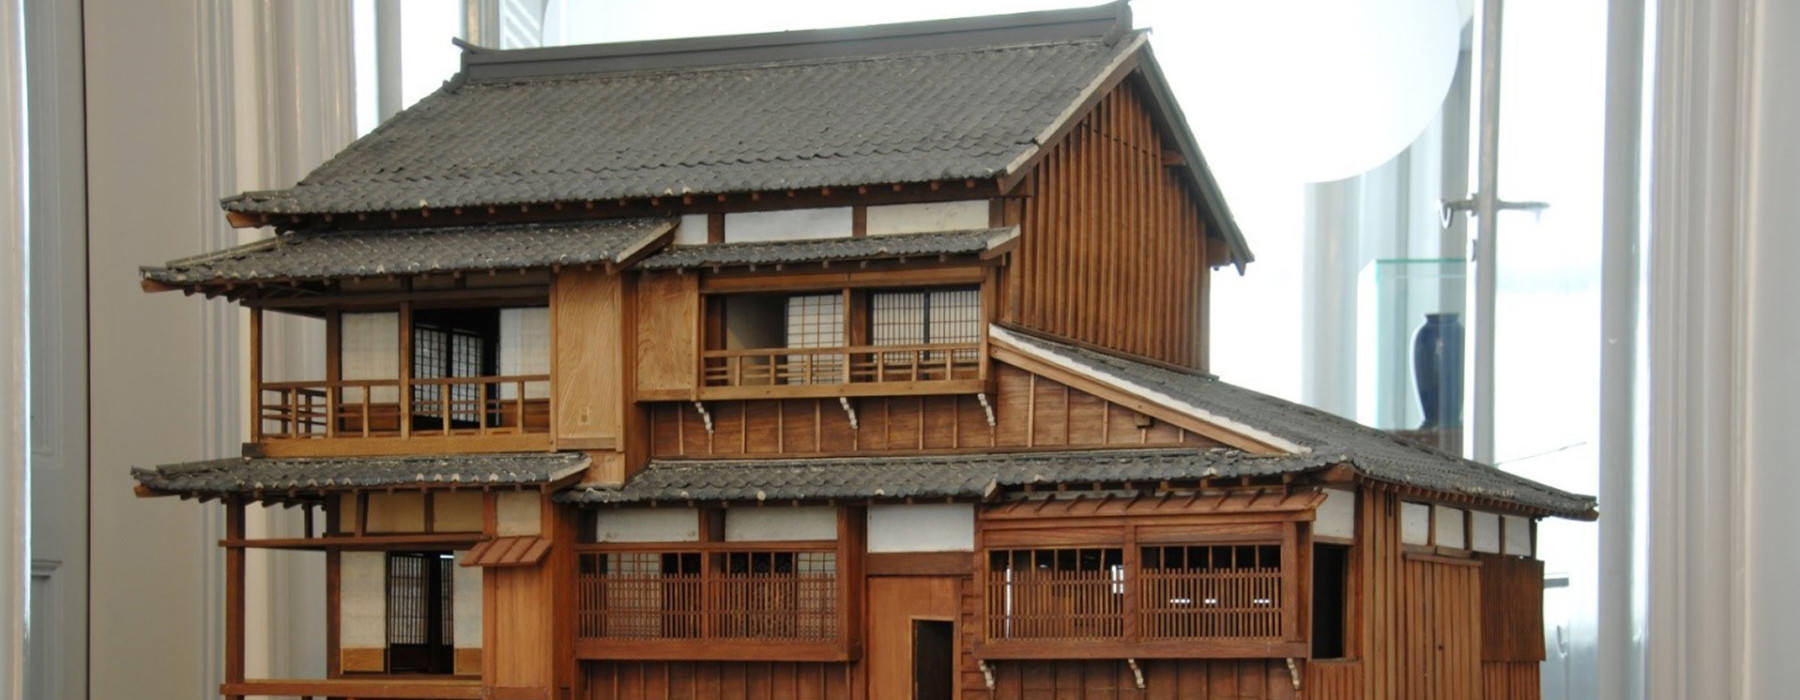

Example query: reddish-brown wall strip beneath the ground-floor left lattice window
[578,660,860,700]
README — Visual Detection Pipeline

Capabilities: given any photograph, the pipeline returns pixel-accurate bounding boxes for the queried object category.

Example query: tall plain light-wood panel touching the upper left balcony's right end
[551,270,625,439]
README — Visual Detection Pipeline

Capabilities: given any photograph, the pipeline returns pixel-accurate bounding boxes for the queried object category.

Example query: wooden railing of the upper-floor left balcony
[256,374,551,439]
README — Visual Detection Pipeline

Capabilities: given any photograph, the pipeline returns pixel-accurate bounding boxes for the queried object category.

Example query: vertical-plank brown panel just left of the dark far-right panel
[1395,556,1481,700]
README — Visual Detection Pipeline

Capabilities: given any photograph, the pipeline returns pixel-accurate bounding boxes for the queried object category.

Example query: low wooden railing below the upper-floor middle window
[704,342,983,396]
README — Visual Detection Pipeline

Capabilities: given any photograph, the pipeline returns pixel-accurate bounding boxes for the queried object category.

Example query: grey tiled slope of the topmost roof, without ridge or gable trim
[225,36,1136,214]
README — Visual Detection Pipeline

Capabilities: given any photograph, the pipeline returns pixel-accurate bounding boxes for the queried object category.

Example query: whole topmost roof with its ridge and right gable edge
[210,0,1251,265]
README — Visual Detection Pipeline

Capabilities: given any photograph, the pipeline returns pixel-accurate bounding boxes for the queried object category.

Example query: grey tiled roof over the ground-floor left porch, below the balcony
[131,452,589,495]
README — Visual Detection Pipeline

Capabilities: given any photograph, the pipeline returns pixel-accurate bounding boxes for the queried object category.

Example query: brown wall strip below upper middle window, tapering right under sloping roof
[648,365,1219,457]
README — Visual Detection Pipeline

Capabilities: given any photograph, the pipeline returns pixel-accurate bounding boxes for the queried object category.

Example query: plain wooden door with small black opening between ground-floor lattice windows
[866,576,961,700]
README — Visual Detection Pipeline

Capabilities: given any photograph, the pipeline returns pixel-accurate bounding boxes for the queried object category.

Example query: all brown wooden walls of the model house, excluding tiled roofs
[133,9,1584,700]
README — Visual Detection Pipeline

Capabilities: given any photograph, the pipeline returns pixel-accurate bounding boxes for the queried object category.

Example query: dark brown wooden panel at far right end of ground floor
[1478,554,1544,662]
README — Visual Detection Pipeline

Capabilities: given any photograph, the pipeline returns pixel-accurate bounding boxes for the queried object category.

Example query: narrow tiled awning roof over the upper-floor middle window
[637,227,1019,270]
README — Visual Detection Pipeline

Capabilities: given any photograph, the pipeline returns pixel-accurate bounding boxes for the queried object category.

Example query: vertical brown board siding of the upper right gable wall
[1006,79,1210,369]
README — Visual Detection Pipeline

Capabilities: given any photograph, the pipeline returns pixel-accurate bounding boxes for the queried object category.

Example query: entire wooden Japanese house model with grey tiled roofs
[133,4,1595,700]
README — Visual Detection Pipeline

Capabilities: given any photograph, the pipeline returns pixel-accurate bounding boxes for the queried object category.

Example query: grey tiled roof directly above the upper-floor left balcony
[144,218,675,284]
